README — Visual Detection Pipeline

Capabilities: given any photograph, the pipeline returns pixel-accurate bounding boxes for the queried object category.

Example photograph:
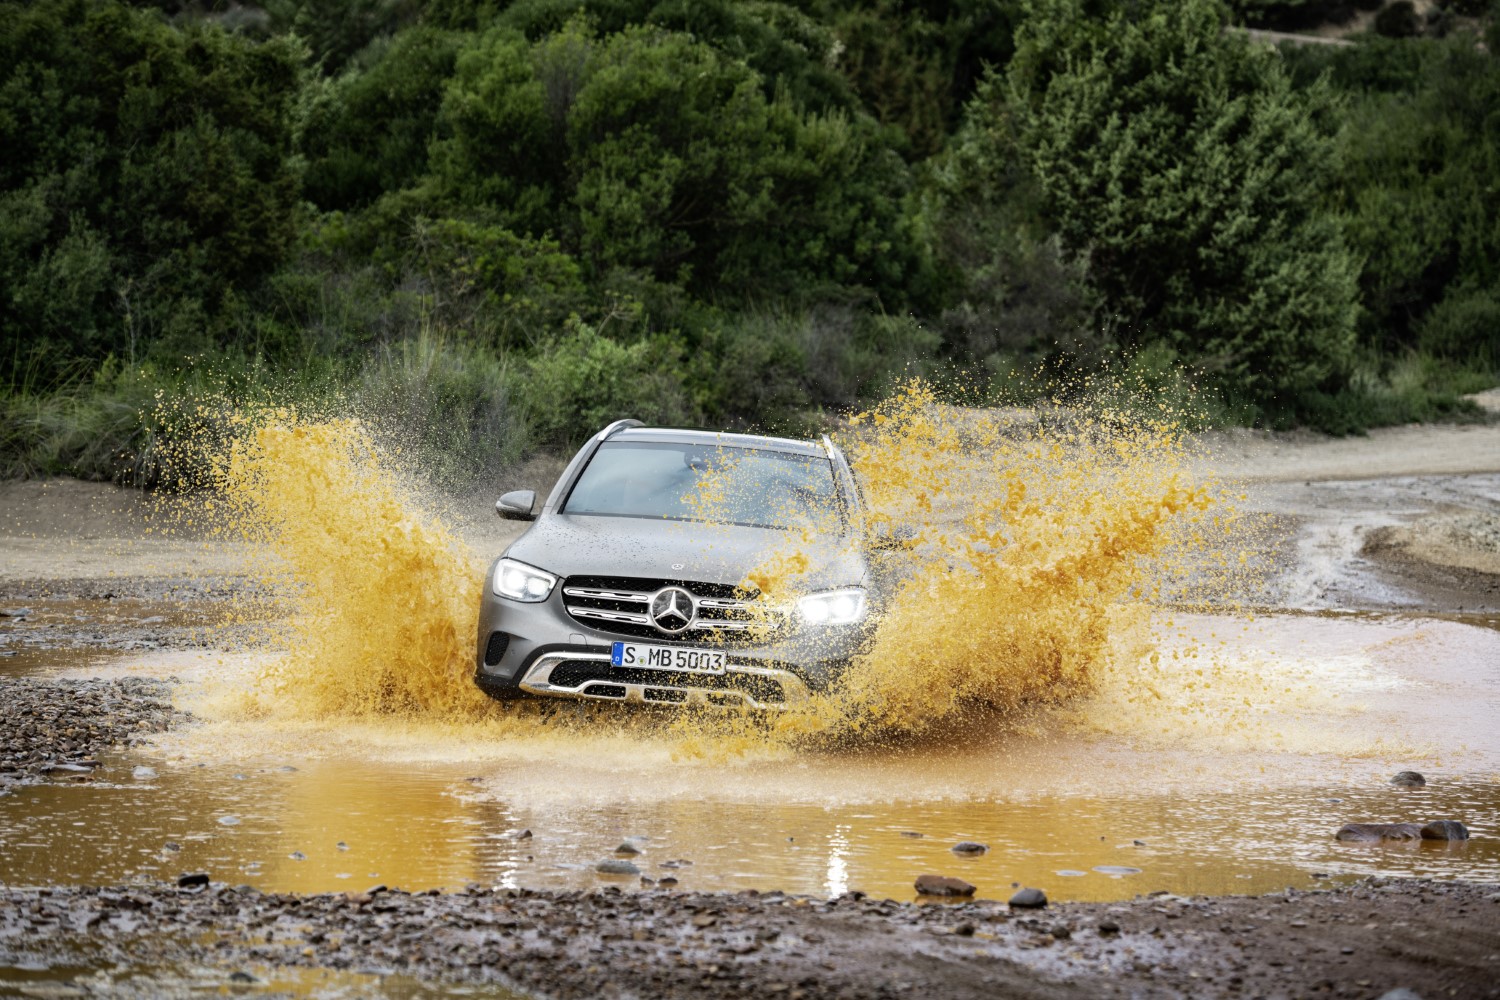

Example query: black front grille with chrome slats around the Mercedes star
[563,576,783,646]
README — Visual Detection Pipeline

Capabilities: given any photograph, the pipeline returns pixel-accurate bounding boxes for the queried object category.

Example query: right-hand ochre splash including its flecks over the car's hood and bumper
[680,382,1245,755]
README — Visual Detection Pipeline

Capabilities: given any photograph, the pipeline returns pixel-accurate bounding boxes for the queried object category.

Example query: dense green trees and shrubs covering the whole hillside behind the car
[0,0,1500,481]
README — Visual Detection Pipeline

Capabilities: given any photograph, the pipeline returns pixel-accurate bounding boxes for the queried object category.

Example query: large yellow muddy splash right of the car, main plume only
[836,385,1214,740]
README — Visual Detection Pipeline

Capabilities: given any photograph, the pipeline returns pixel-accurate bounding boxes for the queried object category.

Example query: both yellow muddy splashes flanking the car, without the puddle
[175,382,1248,756]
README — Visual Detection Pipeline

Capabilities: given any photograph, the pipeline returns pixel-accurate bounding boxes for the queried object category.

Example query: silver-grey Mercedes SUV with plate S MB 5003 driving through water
[476,420,875,708]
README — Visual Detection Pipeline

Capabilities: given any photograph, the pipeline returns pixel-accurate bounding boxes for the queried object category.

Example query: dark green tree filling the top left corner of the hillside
[0,0,300,373]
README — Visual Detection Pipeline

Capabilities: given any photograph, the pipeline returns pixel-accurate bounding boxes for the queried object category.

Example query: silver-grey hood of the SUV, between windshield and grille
[506,514,866,589]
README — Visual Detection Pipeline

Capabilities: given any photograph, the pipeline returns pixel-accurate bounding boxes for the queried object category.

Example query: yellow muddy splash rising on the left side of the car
[207,411,489,718]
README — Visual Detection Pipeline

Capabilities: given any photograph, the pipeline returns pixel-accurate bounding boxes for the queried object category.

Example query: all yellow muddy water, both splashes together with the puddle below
[0,385,1500,900]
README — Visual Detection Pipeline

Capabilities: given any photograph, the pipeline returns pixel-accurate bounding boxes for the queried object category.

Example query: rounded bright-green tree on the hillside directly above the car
[434,19,921,301]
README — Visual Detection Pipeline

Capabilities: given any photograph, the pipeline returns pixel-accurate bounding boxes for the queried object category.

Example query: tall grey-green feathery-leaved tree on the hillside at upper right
[969,0,1358,399]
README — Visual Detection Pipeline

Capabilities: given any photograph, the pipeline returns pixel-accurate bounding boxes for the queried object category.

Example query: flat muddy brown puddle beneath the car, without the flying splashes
[0,613,1500,900]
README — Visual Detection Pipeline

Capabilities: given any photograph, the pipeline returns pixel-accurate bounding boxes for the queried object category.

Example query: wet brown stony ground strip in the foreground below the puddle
[0,879,1500,1000]
